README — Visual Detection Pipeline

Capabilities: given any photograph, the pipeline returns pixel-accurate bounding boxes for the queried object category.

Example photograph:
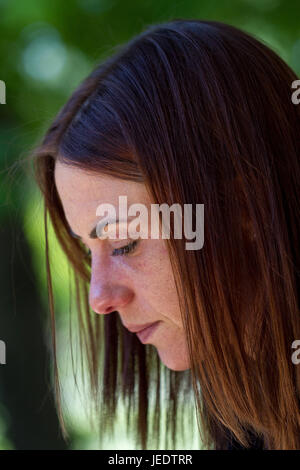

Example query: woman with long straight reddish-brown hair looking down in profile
[31,19,300,449]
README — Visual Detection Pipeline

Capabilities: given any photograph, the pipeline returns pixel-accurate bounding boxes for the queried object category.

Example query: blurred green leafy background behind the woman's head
[0,0,300,449]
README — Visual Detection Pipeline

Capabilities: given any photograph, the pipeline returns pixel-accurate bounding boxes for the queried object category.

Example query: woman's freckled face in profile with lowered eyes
[55,162,190,370]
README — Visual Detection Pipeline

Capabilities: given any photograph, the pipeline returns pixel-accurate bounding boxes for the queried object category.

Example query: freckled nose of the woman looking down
[89,266,134,314]
